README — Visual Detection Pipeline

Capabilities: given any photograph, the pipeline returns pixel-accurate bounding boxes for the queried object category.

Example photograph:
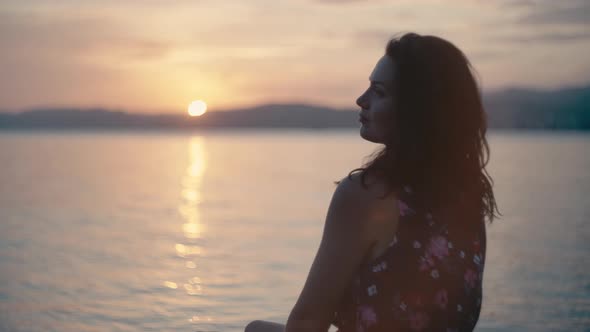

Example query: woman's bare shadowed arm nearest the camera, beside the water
[246,174,390,332]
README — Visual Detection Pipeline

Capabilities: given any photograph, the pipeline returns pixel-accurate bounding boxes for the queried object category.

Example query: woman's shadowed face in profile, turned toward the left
[356,55,395,143]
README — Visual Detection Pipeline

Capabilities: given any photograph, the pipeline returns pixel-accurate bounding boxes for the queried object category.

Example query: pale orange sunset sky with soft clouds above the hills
[0,0,590,113]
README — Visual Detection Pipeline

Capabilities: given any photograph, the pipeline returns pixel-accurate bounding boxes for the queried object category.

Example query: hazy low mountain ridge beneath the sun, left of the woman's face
[0,104,358,128]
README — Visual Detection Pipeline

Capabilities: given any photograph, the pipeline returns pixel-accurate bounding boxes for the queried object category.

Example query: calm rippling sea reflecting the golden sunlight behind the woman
[0,128,590,332]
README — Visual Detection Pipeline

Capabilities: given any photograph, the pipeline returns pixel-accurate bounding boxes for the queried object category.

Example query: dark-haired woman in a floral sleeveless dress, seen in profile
[246,33,497,332]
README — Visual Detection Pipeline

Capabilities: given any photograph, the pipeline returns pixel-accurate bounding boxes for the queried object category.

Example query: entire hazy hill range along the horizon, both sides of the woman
[0,86,590,130]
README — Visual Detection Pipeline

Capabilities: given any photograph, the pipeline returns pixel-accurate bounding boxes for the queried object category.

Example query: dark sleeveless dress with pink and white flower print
[332,186,486,332]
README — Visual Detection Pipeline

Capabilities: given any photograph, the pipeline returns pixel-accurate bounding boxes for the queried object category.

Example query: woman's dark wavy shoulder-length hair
[348,33,499,228]
